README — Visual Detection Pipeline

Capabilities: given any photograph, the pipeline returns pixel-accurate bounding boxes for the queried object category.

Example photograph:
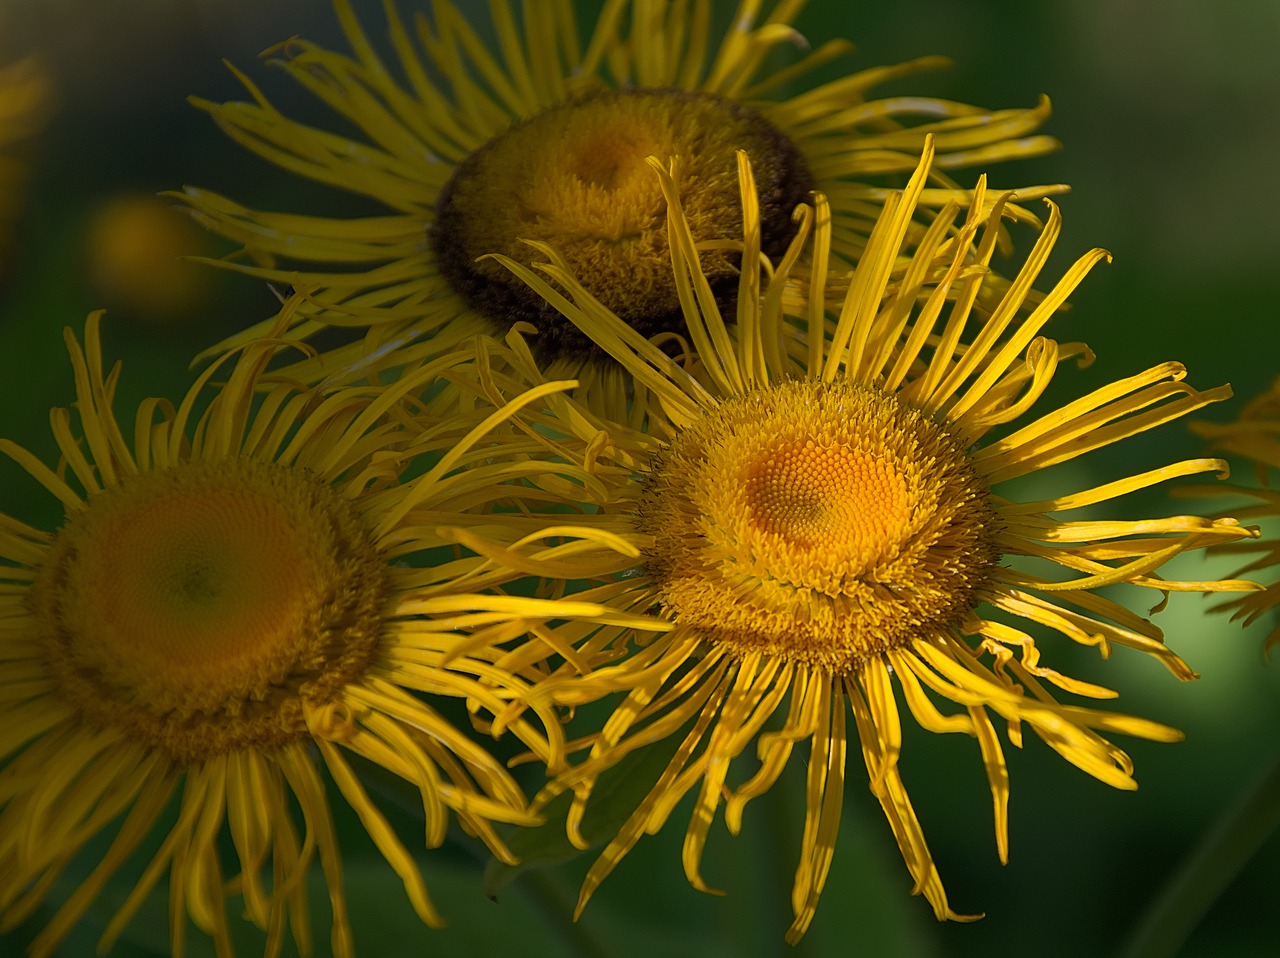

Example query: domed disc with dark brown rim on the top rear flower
[431,90,813,360]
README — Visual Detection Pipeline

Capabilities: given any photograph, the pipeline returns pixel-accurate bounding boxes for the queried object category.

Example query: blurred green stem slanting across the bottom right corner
[1121,753,1280,958]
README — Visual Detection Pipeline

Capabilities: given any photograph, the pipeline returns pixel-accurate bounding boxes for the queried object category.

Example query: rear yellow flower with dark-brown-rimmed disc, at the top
[182,0,1061,399]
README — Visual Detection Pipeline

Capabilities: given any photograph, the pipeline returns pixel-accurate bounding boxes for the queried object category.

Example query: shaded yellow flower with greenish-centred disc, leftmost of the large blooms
[0,315,640,955]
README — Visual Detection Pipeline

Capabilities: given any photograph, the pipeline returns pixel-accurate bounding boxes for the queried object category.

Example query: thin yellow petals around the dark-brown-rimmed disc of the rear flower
[175,0,1064,404]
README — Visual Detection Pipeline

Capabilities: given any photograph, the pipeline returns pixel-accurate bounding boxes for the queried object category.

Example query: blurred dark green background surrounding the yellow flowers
[0,0,1280,958]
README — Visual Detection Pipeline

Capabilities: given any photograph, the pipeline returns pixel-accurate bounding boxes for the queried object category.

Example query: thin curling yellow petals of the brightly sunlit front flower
[453,140,1256,940]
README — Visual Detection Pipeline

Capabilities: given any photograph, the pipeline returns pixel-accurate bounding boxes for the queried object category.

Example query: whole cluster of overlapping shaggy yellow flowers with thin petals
[0,0,1280,955]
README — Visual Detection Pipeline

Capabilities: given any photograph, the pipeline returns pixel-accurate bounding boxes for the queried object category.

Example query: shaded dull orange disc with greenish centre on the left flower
[32,460,388,758]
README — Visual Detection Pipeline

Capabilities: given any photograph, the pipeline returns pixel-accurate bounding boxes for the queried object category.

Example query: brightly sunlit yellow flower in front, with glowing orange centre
[481,147,1254,941]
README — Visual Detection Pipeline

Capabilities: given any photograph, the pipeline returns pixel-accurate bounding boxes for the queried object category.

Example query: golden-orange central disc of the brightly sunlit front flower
[639,382,998,674]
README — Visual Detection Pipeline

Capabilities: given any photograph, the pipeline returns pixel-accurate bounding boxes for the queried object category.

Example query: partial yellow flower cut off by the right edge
[1192,379,1280,653]
